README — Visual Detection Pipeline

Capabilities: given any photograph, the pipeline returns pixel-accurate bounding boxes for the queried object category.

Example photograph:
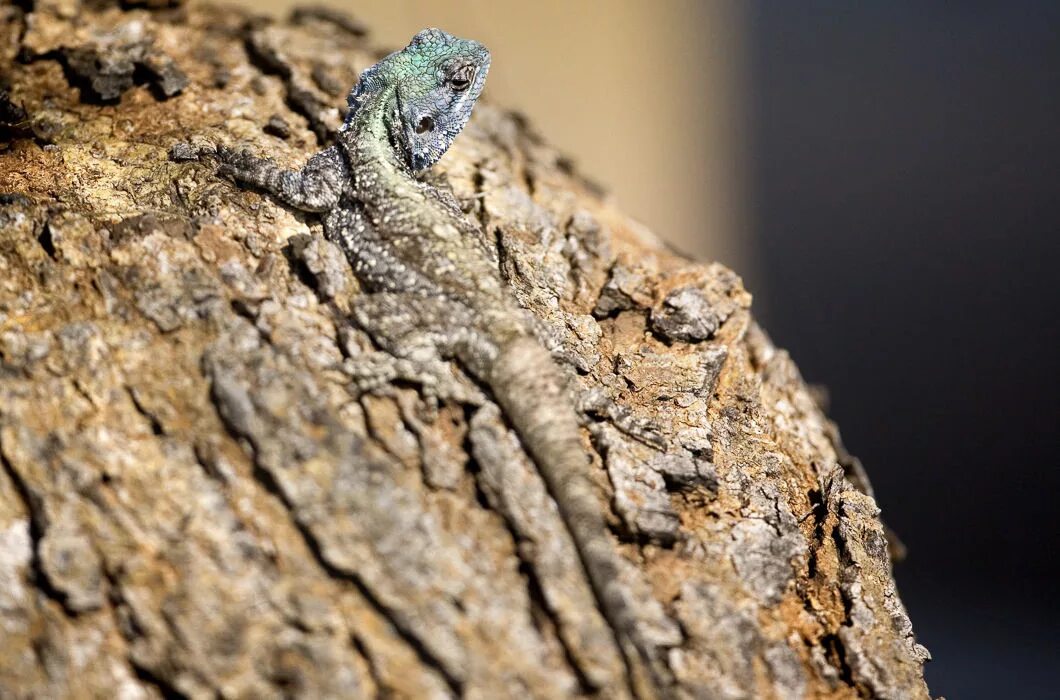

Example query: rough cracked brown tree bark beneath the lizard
[0,0,928,699]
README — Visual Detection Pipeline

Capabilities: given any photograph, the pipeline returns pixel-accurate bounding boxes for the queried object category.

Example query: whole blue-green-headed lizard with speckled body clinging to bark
[191,29,669,697]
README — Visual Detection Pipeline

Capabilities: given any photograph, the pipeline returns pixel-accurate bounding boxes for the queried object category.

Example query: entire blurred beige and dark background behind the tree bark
[234,0,1060,700]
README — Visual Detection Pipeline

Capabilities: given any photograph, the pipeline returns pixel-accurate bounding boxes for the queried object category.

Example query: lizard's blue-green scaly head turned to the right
[347,29,490,171]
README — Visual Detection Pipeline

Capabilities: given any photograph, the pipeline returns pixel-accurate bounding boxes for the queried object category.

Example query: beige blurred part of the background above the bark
[227,0,752,274]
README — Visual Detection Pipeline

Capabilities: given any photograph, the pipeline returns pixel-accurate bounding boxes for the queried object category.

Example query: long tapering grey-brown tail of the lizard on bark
[489,335,658,698]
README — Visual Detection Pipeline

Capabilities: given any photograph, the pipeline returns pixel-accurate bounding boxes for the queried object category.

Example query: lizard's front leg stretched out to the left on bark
[216,145,351,212]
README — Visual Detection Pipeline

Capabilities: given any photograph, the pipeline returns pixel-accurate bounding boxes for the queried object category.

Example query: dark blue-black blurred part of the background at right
[747,0,1060,699]
